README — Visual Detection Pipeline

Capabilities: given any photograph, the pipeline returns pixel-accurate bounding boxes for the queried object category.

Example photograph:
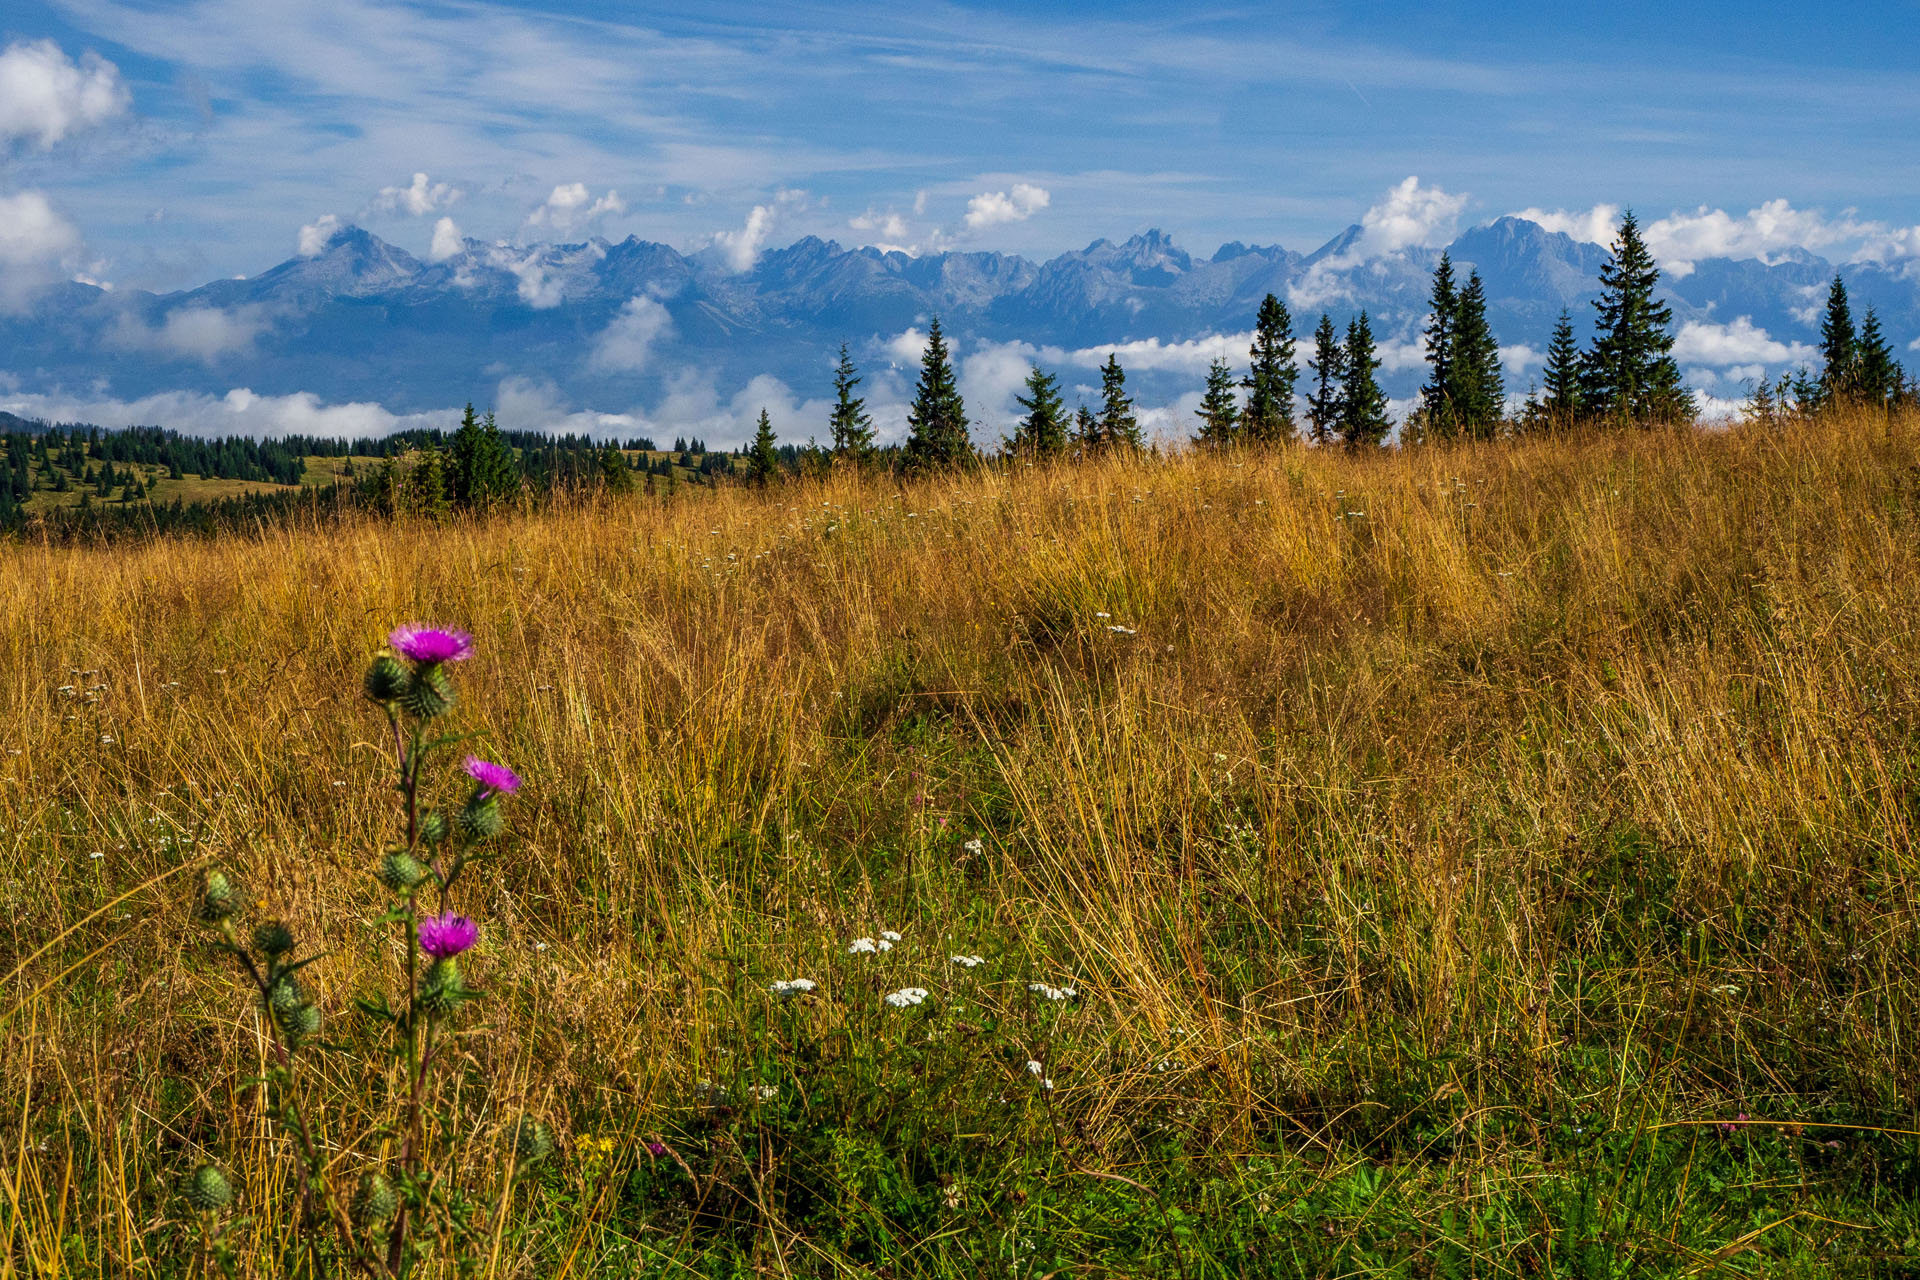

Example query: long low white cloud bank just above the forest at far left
[0,388,459,439]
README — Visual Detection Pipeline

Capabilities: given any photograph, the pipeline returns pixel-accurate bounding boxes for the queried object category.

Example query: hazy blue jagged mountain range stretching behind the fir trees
[0,217,1920,434]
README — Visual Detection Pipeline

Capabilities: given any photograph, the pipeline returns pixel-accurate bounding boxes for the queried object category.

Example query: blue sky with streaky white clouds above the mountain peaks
[0,0,1920,288]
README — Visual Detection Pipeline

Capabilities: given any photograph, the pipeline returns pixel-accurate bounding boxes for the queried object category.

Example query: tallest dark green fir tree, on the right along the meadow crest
[1580,209,1693,426]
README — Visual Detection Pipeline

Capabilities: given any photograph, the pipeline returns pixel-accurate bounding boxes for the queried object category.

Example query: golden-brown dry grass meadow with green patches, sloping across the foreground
[0,415,1920,1280]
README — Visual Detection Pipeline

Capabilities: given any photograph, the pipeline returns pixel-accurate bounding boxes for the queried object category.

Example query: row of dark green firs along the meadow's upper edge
[747,211,1916,484]
